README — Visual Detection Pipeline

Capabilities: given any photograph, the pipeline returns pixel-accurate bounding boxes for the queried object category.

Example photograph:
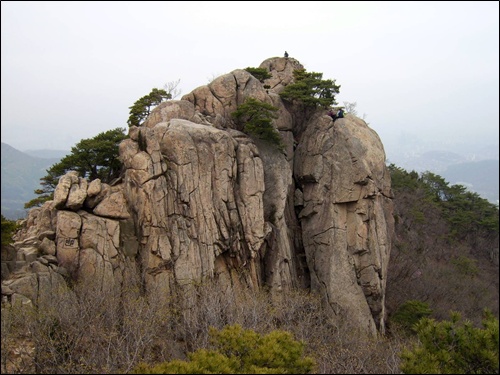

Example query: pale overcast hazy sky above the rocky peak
[1,1,499,161]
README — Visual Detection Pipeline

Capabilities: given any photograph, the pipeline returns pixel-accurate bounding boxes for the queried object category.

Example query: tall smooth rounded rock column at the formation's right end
[295,111,394,331]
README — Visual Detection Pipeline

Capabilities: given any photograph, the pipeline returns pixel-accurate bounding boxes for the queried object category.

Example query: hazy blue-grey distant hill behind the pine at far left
[1,142,61,220]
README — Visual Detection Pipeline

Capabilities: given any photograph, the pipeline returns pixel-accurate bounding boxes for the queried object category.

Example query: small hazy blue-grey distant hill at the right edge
[439,160,499,203]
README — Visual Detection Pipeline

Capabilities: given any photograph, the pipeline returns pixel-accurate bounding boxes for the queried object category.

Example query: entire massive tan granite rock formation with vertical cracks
[2,58,394,335]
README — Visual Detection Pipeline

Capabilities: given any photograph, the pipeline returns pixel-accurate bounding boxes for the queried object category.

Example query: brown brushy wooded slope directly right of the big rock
[386,165,498,324]
